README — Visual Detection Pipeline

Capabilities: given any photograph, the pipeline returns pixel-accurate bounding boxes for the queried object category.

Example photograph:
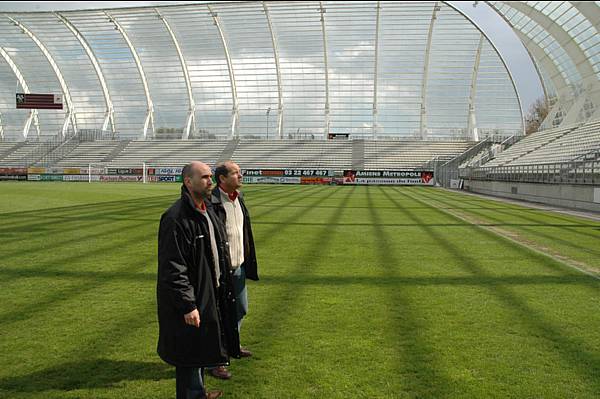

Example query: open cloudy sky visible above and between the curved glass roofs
[0,1,543,113]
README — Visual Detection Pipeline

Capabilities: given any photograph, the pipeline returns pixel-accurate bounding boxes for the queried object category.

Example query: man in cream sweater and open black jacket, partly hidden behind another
[210,161,258,379]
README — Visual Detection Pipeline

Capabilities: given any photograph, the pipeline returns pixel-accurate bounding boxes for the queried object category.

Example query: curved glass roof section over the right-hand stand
[490,1,600,127]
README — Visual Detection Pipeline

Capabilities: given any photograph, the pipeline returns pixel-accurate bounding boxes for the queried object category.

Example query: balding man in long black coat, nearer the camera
[156,162,240,399]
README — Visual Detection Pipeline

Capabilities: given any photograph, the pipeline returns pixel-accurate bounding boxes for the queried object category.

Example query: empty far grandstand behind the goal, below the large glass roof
[0,139,473,170]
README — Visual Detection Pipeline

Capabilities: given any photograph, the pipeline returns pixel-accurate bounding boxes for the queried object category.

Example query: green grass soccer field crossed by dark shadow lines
[0,182,600,399]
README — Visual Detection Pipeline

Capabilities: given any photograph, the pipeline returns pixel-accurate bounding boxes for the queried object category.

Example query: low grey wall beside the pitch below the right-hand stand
[464,180,600,212]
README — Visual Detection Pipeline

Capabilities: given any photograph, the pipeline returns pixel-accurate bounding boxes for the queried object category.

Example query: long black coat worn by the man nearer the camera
[156,186,239,367]
